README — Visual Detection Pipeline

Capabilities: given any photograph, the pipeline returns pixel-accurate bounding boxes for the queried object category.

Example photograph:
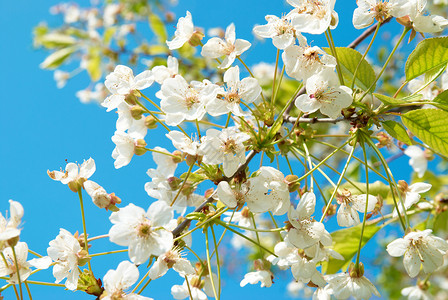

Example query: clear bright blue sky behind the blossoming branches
[0,0,420,300]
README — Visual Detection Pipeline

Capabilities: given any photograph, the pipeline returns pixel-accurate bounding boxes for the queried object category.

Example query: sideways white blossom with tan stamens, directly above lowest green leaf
[337,191,378,227]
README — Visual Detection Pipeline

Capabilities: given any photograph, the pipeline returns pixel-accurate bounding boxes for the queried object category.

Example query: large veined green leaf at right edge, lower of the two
[401,109,448,156]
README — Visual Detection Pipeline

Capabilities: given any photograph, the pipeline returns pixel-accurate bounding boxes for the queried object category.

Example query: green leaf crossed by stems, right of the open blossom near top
[325,47,376,91]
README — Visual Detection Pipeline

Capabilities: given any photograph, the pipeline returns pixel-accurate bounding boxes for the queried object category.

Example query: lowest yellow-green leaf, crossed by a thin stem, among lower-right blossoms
[326,224,381,274]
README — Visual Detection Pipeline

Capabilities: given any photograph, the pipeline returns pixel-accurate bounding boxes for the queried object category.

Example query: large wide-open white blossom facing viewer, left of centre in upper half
[159,75,217,126]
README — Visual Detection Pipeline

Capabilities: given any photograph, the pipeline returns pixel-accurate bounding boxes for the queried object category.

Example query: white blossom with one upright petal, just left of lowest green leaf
[286,192,332,249]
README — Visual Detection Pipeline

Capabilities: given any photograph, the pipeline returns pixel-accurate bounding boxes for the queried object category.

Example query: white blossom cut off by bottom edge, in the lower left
[101,261,152,300]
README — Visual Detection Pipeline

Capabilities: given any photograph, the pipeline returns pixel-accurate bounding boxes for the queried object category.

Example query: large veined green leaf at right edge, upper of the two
[405,37,448,81]
